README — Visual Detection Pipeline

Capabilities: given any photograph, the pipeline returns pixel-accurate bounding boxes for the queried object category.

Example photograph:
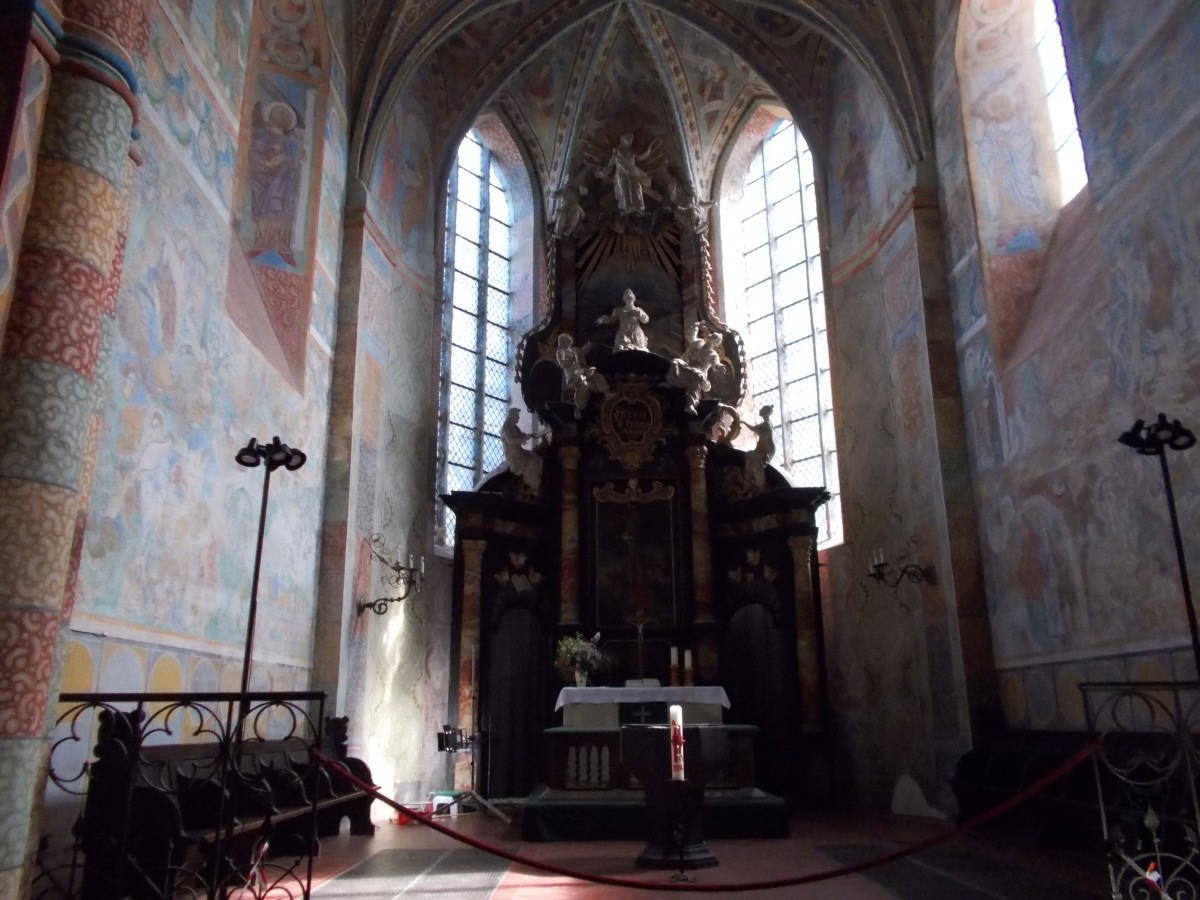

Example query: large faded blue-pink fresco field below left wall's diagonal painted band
[72,118,328,677]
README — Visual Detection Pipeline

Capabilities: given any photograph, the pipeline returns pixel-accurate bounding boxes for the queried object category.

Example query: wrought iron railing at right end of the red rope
[1080,682,1200,900]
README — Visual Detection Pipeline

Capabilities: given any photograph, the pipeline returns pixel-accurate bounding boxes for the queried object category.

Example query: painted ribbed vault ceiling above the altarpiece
[352,0,932,197]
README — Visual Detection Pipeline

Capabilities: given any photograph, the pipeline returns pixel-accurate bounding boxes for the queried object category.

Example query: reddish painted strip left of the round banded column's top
[0,0,62,338]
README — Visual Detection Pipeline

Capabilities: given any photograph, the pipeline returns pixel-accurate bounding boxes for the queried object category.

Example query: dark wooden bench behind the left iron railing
[77,709,374,898]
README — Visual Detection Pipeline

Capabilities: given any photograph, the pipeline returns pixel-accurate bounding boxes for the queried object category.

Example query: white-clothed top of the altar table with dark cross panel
[554,685,730,728]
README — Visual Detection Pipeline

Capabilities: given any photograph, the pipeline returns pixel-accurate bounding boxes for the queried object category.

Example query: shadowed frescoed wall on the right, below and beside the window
[937,0,1200,728]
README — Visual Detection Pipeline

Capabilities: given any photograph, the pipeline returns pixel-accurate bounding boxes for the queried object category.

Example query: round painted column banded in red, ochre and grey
[0,0,149,898]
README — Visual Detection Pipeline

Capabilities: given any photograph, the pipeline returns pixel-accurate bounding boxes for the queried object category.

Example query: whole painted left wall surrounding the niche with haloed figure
[71,0,346,690]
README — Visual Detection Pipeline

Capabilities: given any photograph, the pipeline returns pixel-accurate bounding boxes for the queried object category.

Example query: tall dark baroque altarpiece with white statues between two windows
[444,130,828,798]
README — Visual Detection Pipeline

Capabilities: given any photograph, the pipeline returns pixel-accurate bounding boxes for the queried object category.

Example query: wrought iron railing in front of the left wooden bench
[34,691,335,900]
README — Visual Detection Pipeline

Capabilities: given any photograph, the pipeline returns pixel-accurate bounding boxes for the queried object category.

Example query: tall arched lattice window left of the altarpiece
[436,132,512,546]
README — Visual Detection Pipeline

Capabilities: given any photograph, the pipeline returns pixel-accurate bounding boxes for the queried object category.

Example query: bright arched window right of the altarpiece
[722,119,841,547]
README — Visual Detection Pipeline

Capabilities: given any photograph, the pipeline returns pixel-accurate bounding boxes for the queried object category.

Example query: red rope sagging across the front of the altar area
[313,740,1100,894]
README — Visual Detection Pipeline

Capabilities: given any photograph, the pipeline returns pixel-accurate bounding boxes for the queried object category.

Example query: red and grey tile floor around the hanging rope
[304,806,1109,900]
